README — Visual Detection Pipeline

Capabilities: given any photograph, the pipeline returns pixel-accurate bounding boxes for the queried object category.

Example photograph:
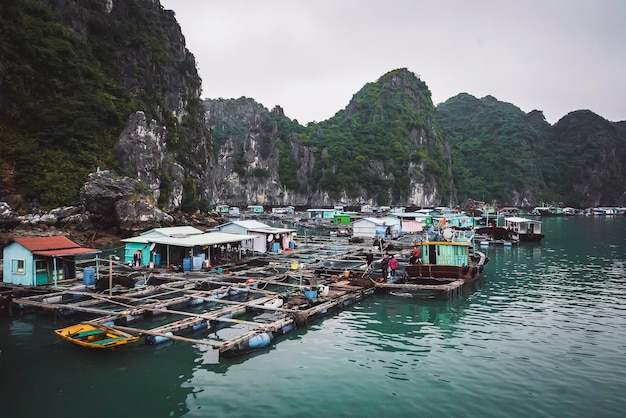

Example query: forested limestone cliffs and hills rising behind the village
[0,0,626,222]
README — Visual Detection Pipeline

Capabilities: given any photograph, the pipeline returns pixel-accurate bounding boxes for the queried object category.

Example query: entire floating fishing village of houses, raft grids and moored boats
[1,207,620,361]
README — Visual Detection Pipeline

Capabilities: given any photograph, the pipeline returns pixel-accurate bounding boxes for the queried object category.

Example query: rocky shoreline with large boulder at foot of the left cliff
[0,171,224,248]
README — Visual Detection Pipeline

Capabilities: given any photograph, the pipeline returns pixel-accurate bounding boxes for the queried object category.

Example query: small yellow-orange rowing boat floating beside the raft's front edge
[54,323,139,348]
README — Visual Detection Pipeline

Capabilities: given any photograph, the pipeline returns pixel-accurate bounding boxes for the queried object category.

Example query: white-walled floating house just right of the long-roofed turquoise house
[214,219,296,254]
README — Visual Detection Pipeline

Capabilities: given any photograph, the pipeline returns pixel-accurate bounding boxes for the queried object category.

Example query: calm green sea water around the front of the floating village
[0,217,626,418]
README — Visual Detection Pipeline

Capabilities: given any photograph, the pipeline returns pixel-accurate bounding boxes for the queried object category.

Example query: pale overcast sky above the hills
[161,0,626,125]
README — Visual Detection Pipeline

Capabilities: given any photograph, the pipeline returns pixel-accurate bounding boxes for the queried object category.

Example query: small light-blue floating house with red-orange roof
[3,235,101,286]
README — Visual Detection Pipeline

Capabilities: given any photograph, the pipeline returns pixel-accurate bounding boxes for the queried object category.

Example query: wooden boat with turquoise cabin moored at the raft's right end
[382,229,489,297]
